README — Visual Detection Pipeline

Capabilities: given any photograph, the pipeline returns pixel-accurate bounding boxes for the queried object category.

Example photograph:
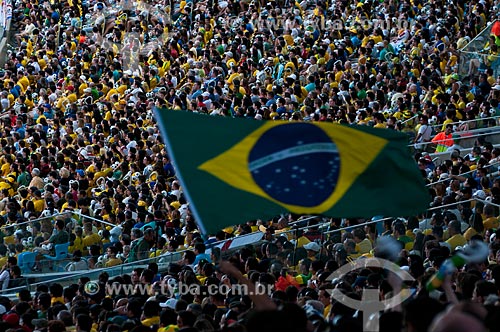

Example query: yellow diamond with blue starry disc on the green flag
[199,122,388,213]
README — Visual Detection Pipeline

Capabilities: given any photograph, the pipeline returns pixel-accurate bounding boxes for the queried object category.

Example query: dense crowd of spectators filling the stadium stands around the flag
[0,0,500,332]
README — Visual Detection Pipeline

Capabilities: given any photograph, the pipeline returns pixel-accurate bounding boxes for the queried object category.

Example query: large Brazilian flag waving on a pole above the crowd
[155,109,430,234]
